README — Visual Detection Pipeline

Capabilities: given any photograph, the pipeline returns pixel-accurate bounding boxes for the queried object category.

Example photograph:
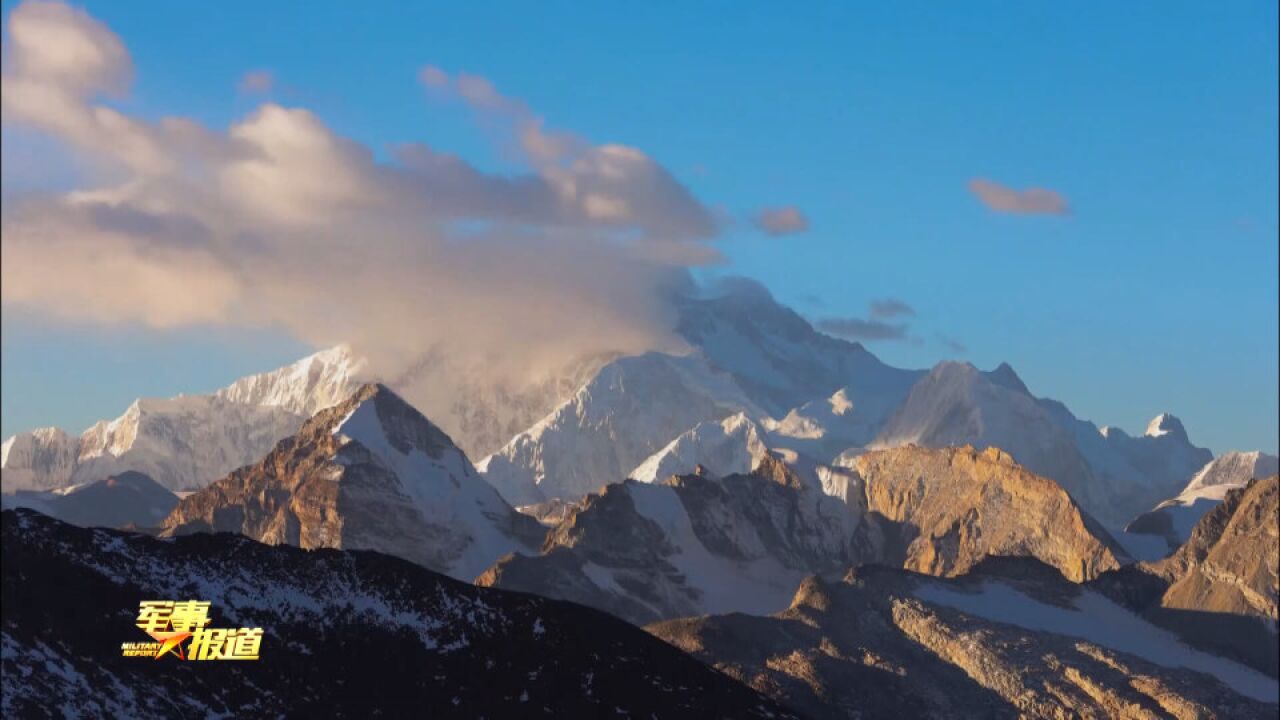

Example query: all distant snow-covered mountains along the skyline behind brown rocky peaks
[0,283,1239,529]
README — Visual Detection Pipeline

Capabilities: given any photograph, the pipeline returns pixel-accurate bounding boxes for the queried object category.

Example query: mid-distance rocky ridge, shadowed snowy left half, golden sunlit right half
[476,447,1123,623]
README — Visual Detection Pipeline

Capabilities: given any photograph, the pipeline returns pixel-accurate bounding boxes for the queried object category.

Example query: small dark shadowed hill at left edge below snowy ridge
[0,471,178,528]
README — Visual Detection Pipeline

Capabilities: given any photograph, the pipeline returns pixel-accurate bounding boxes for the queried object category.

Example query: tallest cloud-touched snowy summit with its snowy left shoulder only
[477,283,920,505]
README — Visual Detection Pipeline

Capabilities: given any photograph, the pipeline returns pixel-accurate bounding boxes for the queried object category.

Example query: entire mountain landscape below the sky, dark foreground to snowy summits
[3,288,1280,717]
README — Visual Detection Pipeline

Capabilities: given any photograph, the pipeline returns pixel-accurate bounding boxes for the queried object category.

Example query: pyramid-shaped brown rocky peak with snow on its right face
[163,384,540,579]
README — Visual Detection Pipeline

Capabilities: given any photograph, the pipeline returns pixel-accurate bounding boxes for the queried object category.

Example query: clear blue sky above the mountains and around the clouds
[0,1,1280,451]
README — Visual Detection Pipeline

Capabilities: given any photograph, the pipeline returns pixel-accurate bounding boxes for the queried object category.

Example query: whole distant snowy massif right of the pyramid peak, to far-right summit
[479,283,1212,528]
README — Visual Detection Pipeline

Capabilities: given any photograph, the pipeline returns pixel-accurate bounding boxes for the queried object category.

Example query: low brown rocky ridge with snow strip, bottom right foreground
[648,560,1277,719]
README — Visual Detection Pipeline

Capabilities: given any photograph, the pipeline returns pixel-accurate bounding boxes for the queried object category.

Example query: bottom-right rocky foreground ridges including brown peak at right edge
[648,477,1280,719]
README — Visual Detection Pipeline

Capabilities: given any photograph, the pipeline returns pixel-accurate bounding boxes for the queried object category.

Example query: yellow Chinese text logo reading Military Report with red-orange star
[120,600,262,660]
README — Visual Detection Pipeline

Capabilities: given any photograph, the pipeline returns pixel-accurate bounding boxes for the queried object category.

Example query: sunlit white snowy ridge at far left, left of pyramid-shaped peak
[0,346,364,493]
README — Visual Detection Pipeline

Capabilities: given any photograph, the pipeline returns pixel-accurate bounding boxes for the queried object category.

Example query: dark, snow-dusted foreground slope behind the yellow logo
[0,510,795,719]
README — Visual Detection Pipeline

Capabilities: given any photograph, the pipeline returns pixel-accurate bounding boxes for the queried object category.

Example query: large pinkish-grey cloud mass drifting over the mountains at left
[0,1,718,443]
